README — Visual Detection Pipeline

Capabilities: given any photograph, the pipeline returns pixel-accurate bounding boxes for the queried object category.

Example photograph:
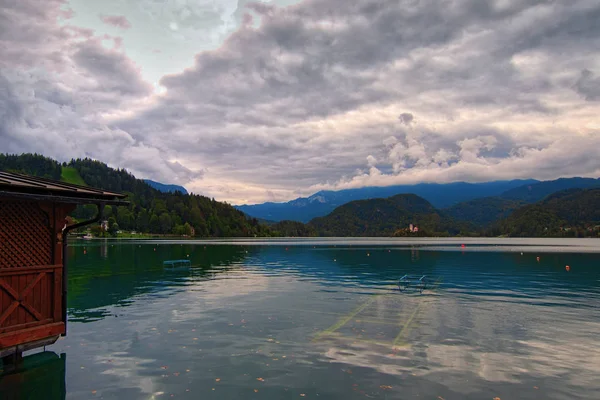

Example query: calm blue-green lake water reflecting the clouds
[0,239,600,400]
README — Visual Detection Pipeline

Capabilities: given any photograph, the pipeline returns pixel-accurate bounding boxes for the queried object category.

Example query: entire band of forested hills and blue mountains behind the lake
[0,154,600,237]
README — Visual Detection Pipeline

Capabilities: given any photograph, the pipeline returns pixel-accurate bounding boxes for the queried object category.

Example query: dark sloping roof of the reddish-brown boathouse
[0,171,126,204]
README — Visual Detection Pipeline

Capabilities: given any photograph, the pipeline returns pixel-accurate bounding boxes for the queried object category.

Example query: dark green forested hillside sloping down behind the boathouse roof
[0,154,272,237]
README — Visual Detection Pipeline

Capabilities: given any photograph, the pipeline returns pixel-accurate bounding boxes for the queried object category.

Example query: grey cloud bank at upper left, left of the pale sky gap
[0,0,202,183]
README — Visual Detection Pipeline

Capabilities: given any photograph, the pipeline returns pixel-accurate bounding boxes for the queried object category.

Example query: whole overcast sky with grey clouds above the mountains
[0,0,600,204]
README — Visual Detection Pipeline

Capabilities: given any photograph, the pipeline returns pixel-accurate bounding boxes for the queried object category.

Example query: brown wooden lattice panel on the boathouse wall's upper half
[0,201,52,268]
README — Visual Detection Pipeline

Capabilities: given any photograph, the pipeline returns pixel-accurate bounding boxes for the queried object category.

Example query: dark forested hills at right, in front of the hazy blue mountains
[304,187,600,237]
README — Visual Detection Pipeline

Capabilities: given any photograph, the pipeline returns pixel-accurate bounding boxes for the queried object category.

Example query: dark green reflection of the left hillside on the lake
[68,241,255,322]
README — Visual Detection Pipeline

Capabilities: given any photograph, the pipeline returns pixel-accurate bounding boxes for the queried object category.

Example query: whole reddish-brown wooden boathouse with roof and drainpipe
[0,172,128,364]
